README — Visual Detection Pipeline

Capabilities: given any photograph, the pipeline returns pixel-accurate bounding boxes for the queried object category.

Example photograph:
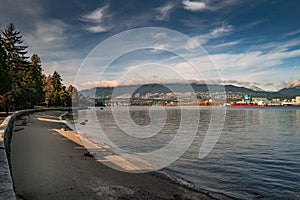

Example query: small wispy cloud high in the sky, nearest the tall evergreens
[80,5,110,33]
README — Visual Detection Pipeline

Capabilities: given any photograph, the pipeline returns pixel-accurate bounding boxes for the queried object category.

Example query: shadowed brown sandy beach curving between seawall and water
[11,111,213,200]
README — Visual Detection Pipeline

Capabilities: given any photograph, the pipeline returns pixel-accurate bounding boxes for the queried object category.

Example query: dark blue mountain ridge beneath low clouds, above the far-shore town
[79,83,300,98]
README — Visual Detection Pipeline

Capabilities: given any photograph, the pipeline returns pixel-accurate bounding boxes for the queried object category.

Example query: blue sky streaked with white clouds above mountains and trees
[0,0,300,91]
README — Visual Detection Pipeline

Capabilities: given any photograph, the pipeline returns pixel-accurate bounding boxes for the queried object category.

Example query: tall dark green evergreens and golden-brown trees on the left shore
[0,23,77,112]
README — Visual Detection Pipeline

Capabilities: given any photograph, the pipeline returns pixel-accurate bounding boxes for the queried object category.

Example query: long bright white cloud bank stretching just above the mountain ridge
[74,42,300,90]
